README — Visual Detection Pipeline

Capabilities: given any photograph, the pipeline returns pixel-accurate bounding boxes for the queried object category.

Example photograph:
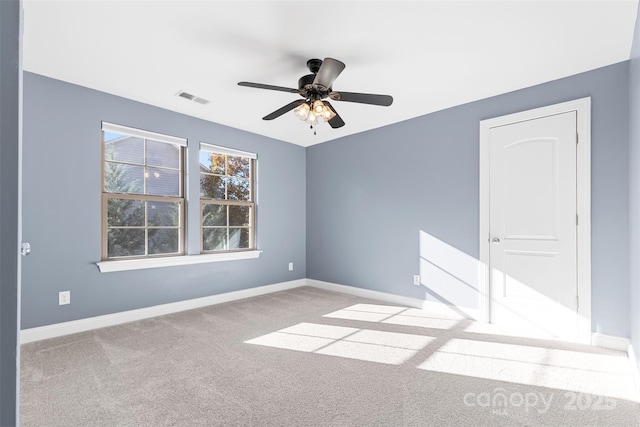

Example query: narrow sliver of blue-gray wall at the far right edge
[629,1,640,378]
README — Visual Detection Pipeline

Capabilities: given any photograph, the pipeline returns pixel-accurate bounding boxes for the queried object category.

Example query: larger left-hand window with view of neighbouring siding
[102,123,186,260]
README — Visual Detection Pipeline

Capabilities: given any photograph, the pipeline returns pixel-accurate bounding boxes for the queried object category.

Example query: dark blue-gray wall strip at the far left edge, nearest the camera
[0,0,22,426]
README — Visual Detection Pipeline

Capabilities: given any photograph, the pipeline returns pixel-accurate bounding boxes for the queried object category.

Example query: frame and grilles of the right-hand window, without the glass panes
[198,142,258,255]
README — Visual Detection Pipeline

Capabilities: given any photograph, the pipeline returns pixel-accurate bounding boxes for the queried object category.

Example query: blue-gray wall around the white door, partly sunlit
[307,62,629,336]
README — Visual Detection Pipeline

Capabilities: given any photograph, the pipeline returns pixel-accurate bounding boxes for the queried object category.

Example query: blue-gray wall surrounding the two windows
[22,73,306,328]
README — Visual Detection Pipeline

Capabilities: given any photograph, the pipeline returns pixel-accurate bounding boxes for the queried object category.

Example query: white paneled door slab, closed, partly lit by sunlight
[489,111,578,339]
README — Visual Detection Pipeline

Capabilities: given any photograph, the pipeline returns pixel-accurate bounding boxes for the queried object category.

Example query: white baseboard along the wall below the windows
[20,279,306,344]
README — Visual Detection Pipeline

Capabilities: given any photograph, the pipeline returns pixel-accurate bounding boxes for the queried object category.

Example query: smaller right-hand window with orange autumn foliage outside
[200,143,257,252]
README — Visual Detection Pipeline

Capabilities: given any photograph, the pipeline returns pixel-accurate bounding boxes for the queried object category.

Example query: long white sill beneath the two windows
[96,251,262,273]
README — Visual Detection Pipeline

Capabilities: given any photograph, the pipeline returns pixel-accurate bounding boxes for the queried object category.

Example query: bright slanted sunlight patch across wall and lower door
[420,230,583,341]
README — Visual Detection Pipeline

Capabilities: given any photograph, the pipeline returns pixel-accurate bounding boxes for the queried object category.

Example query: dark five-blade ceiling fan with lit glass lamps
[238,58,393,134]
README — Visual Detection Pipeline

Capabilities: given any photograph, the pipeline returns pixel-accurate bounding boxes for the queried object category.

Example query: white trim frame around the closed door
[478,97,591,344]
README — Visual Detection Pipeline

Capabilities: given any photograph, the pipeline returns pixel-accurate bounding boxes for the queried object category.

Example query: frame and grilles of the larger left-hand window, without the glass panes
[100,122,187,262]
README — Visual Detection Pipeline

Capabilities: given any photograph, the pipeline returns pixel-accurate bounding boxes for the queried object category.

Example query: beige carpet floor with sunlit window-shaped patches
[20,287,640,427]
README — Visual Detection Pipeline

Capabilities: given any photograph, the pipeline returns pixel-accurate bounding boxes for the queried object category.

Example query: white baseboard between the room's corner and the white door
[307,279,480,320]
